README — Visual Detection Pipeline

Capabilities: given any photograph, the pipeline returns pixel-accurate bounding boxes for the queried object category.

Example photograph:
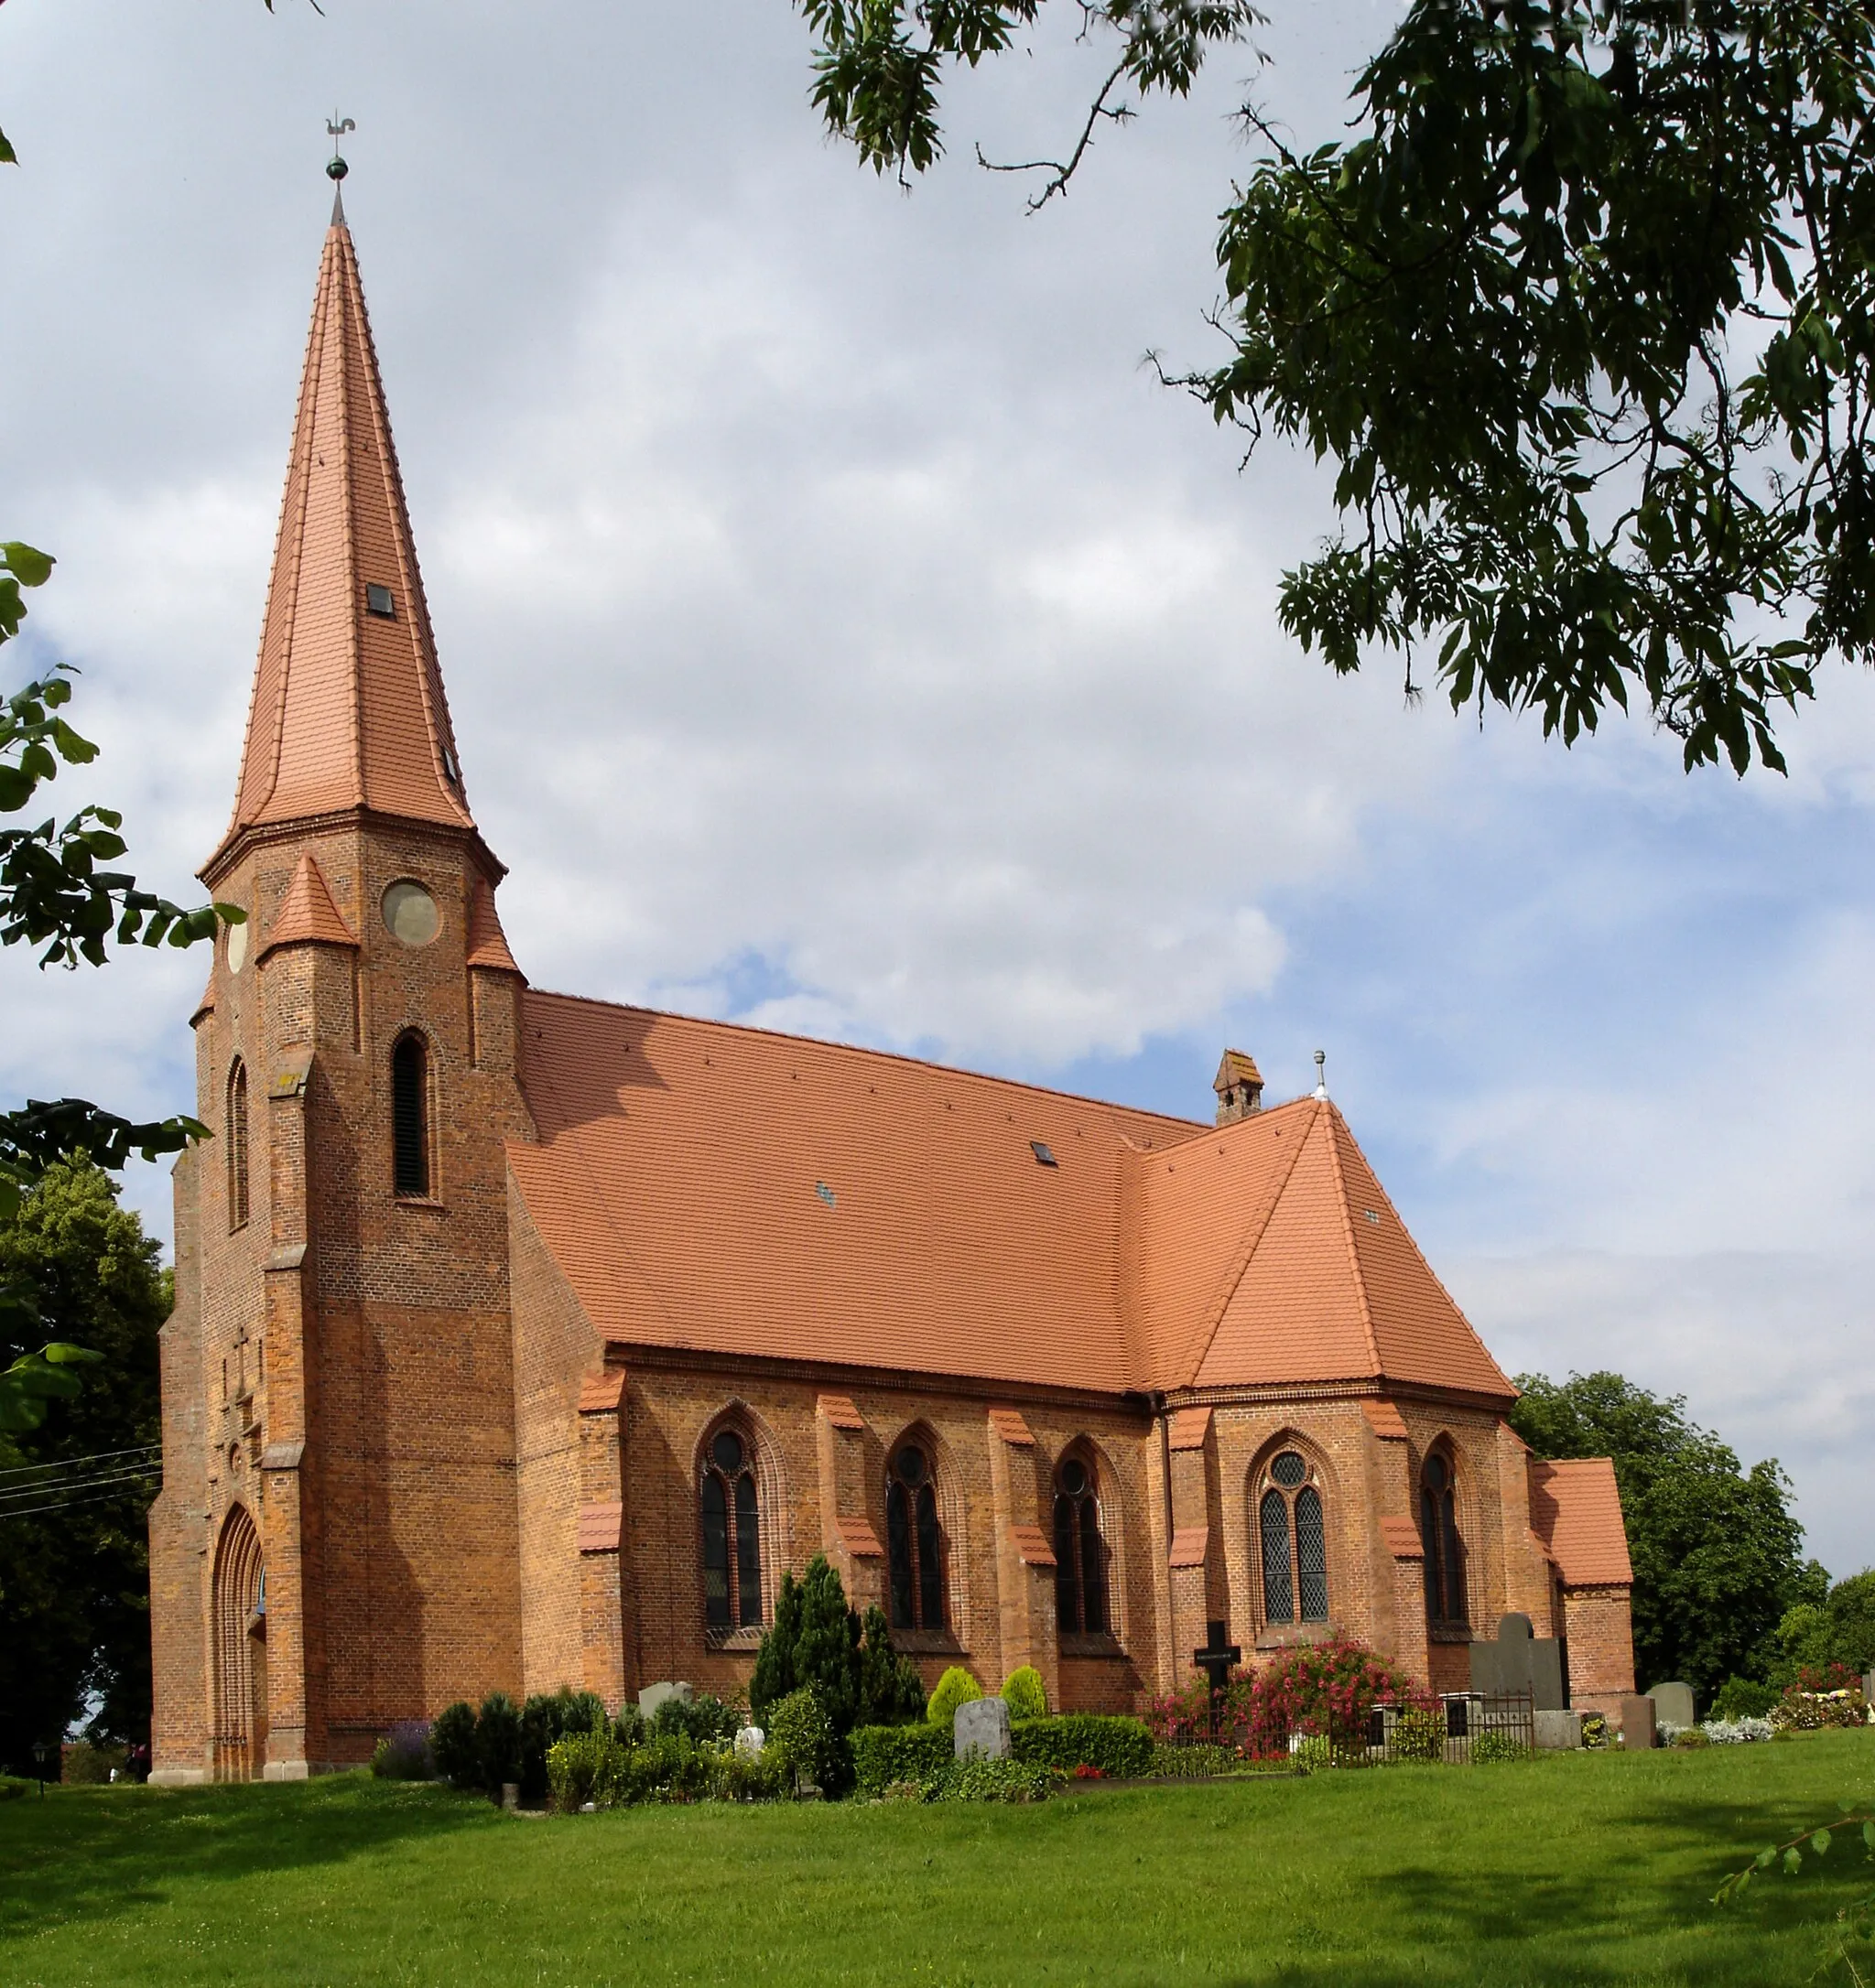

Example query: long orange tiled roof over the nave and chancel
[509,992,1515,1399]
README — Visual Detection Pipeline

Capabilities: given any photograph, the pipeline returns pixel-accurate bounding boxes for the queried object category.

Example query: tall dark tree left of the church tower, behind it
[0,1161,171,1771]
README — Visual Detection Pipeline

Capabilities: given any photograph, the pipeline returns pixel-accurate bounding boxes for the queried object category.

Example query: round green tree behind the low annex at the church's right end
[1509,1372,1827,1700]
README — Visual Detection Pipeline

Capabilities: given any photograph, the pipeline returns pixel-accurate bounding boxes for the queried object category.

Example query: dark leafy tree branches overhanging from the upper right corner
[799,0,1875,773]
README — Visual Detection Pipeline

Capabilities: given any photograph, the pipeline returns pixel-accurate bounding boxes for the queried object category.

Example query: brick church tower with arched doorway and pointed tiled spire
[151,203,533,1781]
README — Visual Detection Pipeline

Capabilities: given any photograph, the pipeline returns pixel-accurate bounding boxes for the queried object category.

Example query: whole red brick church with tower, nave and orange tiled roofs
[149,209,1632,1783]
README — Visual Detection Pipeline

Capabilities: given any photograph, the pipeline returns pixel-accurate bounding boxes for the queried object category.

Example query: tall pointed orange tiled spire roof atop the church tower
[211,203,475,867]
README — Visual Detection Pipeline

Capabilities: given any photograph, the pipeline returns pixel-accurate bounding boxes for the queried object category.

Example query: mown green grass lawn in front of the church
[0,1734,1875,1988]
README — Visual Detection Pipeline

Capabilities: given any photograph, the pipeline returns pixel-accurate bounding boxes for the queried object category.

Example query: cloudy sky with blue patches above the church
[0,0,1875,1574]
